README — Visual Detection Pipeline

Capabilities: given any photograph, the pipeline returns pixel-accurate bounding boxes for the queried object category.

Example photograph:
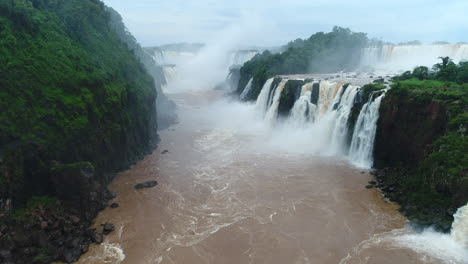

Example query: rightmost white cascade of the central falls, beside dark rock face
[349,92,385,168]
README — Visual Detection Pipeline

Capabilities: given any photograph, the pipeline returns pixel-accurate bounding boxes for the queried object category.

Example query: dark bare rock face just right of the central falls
[374,96,448,168]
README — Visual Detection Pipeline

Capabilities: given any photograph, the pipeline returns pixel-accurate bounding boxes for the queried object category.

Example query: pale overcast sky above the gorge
[104,0,468,46]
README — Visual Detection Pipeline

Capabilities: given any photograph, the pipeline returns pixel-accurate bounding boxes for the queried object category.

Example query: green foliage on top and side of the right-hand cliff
[387,60,468,227]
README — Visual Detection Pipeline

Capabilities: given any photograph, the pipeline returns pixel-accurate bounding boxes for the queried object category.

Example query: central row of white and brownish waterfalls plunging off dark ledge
[252,78,384,168]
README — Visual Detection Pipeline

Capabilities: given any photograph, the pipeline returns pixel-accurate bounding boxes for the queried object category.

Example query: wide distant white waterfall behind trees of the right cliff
[361,44,468,72]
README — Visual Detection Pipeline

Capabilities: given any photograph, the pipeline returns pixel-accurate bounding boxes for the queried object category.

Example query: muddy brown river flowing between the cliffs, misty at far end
[78,89,461,264]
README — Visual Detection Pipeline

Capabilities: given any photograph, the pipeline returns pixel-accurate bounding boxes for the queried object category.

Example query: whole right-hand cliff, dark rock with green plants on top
[374,61,468,231]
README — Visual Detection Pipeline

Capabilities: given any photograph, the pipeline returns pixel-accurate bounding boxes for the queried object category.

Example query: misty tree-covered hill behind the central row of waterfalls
[237,27,371,100]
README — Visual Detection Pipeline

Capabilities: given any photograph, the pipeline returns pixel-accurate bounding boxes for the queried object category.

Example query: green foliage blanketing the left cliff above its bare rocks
[0,0,156,206]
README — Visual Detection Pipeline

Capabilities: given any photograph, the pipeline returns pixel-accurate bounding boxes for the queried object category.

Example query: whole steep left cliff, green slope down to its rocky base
[0,0,165,263]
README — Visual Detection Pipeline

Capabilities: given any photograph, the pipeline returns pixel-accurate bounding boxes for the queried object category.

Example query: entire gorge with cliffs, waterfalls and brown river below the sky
[0,0,468,264]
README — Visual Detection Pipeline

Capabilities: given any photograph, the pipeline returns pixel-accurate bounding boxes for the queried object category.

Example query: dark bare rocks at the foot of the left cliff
[0,204,102,263]
